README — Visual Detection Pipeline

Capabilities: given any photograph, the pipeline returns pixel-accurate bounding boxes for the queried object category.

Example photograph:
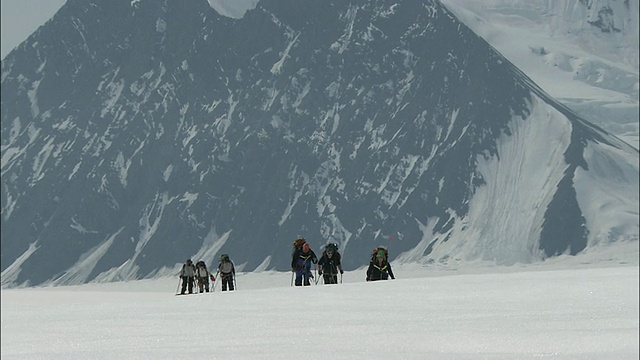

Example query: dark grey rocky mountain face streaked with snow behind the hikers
[1,0,638,284]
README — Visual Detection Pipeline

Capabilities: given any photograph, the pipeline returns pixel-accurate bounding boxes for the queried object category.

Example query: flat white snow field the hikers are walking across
[1,241,640,360]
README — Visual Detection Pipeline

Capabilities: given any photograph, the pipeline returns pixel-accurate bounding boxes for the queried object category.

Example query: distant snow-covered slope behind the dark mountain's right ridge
[442,0,639,149]
